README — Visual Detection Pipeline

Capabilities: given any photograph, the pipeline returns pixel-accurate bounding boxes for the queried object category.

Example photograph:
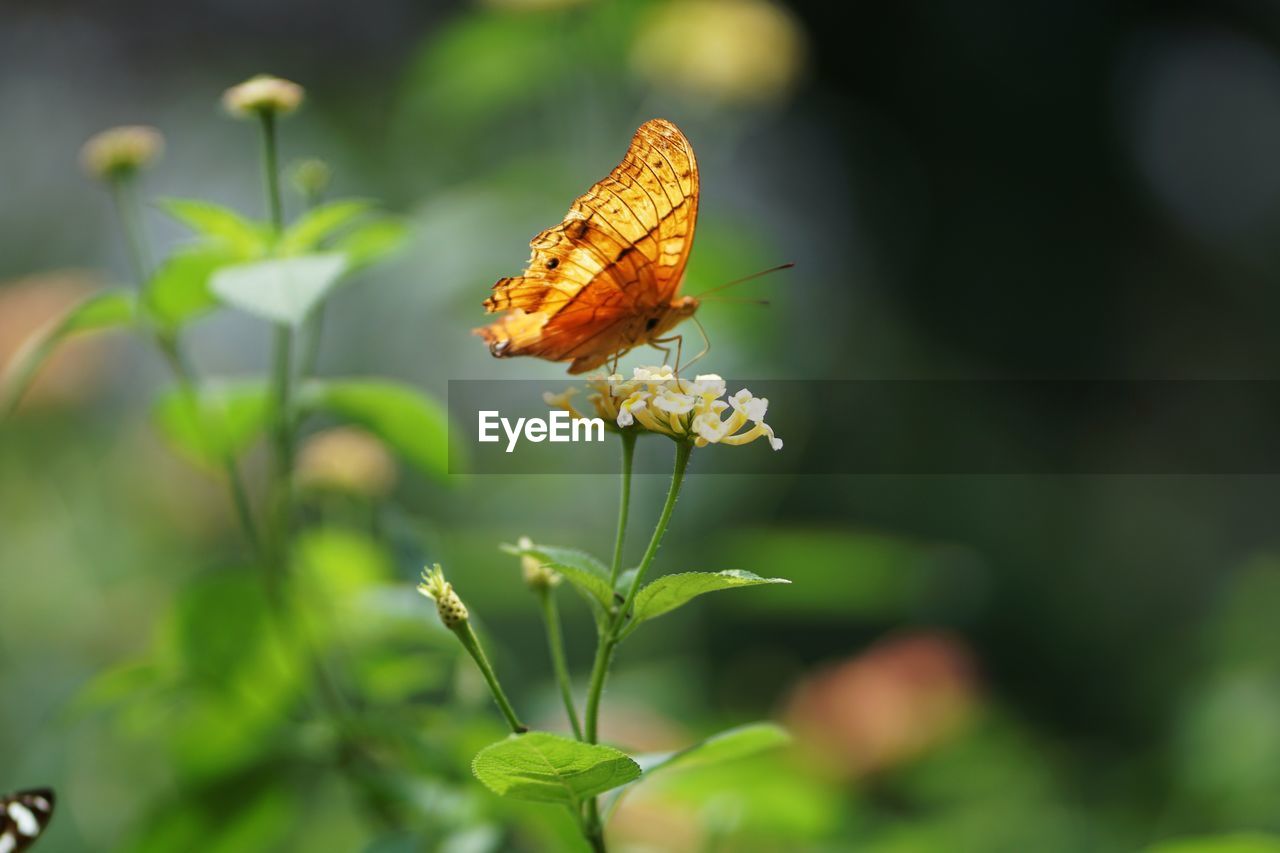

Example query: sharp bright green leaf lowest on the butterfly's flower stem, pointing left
[471,731,640,808]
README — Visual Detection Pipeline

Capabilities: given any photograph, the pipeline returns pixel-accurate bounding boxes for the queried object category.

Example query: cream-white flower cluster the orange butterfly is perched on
[544,365,782,450]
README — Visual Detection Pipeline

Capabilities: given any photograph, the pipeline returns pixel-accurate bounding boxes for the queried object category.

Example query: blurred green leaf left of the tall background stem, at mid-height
[154,379,271,467]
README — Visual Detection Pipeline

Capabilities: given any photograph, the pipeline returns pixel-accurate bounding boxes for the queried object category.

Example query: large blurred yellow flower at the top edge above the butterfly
[631,0,805,104]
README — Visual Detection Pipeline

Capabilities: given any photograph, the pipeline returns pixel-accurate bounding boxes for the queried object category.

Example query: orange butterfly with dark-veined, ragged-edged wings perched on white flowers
[475,119,698,373]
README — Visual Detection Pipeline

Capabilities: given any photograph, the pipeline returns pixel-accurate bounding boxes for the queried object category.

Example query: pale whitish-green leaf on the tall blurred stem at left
[210,252,347,325]
